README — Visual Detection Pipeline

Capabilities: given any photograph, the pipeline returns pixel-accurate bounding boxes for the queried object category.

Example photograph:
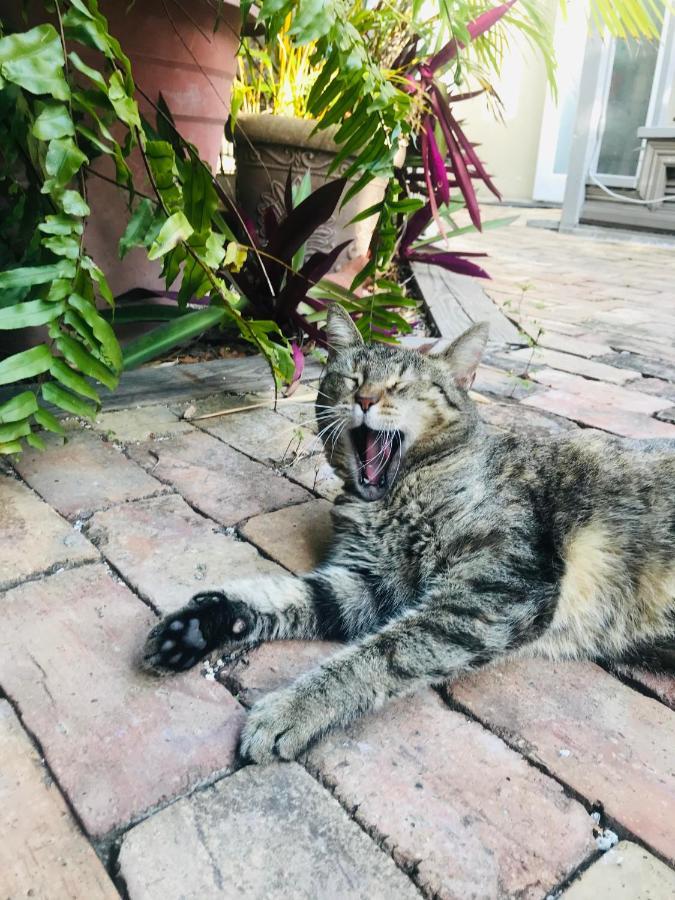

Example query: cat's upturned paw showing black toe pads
[142,591,254,672]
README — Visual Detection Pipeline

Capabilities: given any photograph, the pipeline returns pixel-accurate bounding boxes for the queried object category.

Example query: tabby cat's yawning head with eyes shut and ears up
[316,306,487,500]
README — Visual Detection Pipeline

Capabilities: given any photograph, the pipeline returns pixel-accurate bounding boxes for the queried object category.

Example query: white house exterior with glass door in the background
[464,0,675,232]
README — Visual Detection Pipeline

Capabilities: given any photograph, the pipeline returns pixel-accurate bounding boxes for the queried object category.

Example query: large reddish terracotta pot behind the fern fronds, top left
[85,0,240,296]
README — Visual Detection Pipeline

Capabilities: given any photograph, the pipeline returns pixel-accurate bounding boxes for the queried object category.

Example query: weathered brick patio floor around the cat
[0,211,675,900]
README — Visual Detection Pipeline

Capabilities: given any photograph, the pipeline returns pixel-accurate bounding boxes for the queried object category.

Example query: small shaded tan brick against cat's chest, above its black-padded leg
[242,500,333,572]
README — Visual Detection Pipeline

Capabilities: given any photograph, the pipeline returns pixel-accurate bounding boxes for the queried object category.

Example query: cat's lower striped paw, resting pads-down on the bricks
[239,687,326,764]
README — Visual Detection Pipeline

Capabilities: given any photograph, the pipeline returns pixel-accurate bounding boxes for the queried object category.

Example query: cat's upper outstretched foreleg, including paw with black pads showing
[143,564,369,672]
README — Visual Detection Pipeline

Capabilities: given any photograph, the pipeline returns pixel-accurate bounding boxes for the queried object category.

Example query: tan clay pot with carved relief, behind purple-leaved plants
[234,113,394,269]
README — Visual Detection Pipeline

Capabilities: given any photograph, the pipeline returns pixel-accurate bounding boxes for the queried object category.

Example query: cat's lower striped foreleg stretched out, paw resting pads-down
[240,580,554,763]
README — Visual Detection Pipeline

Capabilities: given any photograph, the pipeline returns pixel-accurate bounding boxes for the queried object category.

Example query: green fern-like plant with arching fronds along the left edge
[0,0,294,453]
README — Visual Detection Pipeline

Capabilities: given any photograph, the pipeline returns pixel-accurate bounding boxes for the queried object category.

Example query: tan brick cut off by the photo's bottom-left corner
[0,700,119,900]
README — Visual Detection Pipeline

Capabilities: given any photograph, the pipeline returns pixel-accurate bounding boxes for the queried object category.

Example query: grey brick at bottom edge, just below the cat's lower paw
[119,763,419,900]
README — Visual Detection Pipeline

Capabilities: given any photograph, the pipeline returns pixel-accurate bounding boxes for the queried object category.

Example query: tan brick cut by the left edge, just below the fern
[0,476,98,589]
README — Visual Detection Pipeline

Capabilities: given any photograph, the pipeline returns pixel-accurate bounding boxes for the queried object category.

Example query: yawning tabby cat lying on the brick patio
[144,306,675,762]
